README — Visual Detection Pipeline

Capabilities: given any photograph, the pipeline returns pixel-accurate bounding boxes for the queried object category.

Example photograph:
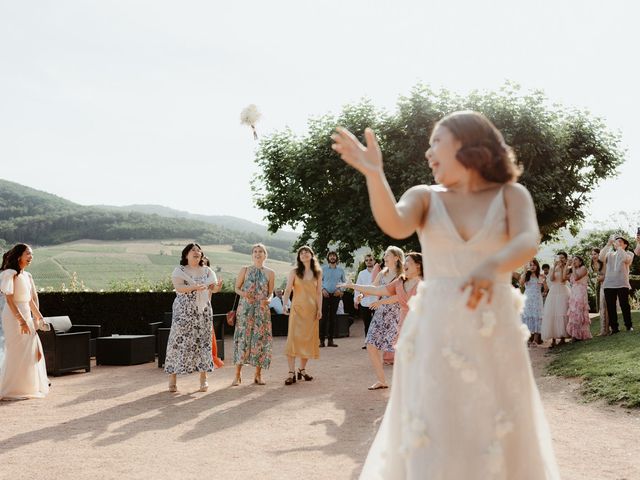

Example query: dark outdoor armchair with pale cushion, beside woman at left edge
[38,316,95,376]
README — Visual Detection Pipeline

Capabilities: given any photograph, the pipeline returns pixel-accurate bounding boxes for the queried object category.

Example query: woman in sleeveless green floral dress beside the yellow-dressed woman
[231,243,275,387]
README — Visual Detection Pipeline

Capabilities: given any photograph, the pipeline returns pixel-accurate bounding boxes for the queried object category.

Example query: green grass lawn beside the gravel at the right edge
[547,311,640,408]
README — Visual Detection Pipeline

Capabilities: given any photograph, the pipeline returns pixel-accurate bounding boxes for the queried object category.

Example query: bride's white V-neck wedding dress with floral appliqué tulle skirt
[360,189,559,480]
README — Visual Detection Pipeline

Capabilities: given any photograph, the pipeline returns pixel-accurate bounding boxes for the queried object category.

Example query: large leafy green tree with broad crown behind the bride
[252,84,623,263]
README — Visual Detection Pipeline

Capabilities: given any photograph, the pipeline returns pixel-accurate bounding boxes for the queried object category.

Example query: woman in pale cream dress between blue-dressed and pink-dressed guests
[540,252,571,348]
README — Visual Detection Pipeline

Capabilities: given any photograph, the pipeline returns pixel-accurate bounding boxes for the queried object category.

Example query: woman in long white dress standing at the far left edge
[0,243,49,400]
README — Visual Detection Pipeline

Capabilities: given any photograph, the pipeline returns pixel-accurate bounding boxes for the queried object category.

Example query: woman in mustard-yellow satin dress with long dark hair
[282,245,322,385]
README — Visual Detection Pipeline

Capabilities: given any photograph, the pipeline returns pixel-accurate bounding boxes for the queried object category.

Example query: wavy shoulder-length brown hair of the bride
[434,111,522,183]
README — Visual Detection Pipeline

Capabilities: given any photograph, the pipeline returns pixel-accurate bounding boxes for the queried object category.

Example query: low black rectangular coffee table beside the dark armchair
[96,335,156,365]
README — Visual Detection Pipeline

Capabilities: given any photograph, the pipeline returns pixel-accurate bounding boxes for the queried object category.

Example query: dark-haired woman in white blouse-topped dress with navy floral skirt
[164,243,222,392]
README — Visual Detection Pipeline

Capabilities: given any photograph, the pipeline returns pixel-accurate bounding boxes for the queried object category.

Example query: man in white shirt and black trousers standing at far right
[600,236,633,334]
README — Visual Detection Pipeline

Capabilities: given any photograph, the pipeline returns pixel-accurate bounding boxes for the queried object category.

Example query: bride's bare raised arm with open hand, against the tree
[331,128,430,238]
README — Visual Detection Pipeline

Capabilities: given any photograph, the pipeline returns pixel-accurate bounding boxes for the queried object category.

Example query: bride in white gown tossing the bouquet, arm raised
[333,112,559,480]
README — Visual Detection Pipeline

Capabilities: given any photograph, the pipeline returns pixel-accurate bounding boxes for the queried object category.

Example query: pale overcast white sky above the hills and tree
[0,0,640,232]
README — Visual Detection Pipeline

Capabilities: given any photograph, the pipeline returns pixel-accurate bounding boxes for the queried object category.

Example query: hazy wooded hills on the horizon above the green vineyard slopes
[0,179,295,260]
